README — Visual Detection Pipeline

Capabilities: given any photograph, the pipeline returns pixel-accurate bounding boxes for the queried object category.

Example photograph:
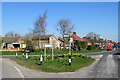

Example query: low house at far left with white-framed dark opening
[1,37,26,49]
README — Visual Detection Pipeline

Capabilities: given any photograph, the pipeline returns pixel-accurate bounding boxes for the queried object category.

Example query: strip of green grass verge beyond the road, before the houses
[2,49,105,55]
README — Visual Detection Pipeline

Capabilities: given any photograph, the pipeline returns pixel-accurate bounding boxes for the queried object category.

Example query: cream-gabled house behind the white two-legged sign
[32,35,60,49]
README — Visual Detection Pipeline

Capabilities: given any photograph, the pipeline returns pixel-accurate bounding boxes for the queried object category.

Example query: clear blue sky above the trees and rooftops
[2,2,118,41]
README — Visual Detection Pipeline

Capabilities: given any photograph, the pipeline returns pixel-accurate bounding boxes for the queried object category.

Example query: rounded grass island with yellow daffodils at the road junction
[10,55,95,73]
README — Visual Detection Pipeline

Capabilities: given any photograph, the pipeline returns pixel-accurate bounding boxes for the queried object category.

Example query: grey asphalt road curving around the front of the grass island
[0,51,118,78]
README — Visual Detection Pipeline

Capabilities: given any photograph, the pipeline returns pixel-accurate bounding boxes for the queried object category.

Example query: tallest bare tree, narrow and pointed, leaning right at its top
[33,10,47,48]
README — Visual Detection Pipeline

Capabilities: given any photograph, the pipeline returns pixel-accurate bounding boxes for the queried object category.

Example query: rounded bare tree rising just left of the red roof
[56,19,74,48]
